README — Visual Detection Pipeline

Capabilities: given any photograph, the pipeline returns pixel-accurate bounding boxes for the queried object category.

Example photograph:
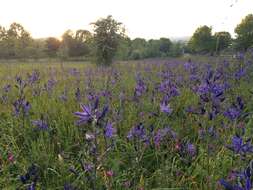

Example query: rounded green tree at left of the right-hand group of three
[189,26,215,53]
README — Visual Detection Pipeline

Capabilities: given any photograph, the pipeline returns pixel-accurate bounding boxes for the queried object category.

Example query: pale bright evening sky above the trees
[0,0,253,39]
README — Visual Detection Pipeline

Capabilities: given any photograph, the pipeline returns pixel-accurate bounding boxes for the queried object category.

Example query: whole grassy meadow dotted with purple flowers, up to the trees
[0,52,253,190]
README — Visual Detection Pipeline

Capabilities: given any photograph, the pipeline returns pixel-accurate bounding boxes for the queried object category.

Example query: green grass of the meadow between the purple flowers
[0,58,253,190]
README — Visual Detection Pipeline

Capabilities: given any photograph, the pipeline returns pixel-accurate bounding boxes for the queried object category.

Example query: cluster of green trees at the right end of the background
[187,14,253,54]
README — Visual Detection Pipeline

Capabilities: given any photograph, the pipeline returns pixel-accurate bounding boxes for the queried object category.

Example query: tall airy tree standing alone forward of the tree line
[92,16,125,65]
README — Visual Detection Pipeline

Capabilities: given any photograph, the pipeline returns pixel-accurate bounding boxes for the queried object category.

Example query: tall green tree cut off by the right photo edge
[235,14,253,51]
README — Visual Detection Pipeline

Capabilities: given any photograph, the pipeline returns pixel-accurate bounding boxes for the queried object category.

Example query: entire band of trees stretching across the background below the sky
[0,14,253,64]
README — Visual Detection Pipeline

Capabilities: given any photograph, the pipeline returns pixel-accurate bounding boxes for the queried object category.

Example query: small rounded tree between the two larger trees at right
[214,32,232,52]
